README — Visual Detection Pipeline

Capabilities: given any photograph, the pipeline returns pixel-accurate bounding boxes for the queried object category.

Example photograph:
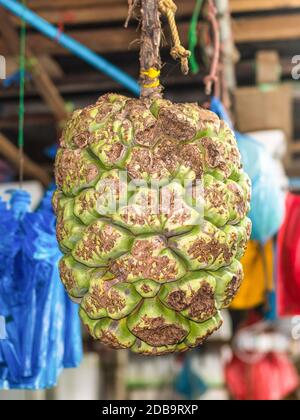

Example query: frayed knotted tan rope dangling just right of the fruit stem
[158,0,191,75]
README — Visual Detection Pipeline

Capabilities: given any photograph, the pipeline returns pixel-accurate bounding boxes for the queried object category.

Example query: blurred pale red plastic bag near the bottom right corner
[225,353,299,401]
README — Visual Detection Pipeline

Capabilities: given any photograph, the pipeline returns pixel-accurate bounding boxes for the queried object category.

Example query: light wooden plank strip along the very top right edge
[230,0,300,13]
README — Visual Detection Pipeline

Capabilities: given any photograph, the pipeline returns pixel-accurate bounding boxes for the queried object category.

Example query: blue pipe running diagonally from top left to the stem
[0,0,140,96]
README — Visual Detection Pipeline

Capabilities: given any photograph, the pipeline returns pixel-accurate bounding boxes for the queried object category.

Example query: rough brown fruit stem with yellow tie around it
[140,0,163,98]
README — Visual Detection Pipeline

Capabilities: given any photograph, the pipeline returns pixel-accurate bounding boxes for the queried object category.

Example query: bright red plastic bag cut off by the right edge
[277,193,300,316]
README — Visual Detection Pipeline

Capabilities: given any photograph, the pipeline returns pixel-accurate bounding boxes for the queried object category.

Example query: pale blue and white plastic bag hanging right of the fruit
[211,98,285,243]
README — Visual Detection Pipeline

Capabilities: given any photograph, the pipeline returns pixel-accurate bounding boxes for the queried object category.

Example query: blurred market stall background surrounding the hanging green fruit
[0,0,300,400]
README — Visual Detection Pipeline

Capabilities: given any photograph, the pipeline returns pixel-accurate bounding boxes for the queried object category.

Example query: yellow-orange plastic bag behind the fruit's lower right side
[231,239,274,310]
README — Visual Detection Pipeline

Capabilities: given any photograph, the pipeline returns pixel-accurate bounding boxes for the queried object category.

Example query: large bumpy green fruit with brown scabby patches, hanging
[53,94,251,355]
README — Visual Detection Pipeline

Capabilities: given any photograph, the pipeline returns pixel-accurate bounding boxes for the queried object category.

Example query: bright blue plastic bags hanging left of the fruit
[0,191,82,389]
